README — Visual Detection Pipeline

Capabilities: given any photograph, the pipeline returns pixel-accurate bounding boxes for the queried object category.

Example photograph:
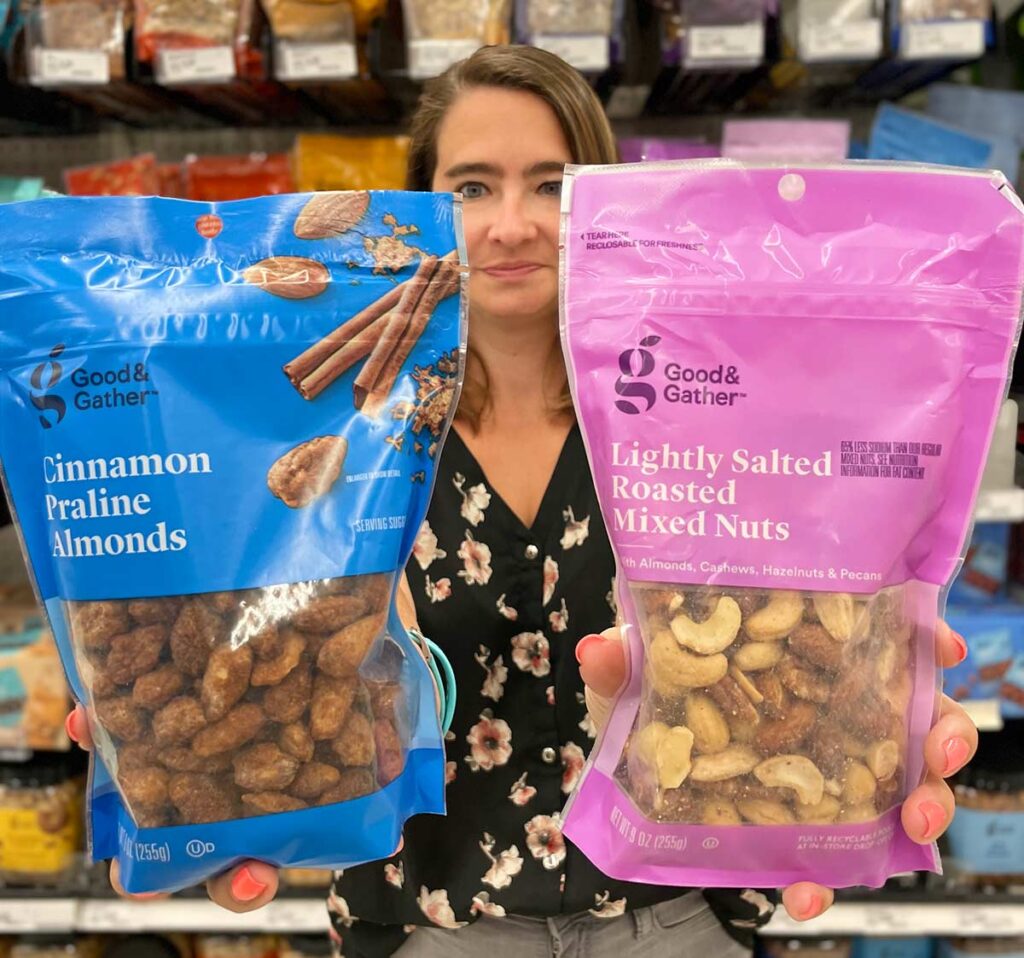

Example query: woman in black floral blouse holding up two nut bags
[66,47,977,958]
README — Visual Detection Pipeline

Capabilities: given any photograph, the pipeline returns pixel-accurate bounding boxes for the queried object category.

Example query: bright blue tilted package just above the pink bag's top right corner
[867,103,993,169]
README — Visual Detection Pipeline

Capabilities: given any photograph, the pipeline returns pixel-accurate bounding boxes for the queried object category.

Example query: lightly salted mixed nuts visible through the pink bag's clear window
[618,585,914,825]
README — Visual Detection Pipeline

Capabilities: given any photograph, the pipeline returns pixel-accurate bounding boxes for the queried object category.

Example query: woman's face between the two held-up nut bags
[433,87,571,322]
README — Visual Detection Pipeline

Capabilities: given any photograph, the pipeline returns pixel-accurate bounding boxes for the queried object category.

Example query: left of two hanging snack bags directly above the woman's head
[401,0,512,80]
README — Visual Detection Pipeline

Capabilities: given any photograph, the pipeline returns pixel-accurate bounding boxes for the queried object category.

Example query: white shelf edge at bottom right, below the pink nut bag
[763,902,1024,937]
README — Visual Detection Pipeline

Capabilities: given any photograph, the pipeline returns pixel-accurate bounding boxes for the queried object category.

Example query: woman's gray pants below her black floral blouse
[395,891,750,958]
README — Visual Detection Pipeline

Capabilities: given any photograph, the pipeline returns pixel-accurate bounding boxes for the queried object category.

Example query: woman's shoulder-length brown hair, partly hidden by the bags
[406,46,618,430]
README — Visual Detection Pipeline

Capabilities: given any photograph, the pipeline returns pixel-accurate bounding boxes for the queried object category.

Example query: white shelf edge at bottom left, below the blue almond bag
[0,897,329,934]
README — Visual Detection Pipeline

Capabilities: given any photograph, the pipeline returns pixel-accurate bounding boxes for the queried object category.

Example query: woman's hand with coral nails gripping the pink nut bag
[575,622,978,921]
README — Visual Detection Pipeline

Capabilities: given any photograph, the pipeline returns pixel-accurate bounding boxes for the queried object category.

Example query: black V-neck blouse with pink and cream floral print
[329,426,773,958]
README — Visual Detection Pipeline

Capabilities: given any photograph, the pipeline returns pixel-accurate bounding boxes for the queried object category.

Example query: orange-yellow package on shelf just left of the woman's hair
[292,133,409,192]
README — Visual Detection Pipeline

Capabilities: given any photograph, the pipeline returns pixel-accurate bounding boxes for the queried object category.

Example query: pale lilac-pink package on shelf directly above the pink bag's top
[722,120,850,163]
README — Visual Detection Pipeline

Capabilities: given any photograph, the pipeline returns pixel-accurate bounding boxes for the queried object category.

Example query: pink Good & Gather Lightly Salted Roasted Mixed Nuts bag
[562,161,1024,887]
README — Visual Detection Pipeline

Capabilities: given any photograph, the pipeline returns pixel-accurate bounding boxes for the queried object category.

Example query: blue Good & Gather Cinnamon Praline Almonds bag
[0,191,466,892]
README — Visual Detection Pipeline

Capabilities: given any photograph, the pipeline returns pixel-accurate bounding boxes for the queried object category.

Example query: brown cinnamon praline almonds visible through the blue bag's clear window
[66,574,404,827]
